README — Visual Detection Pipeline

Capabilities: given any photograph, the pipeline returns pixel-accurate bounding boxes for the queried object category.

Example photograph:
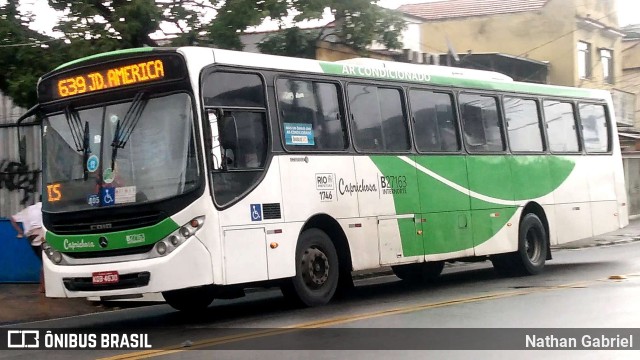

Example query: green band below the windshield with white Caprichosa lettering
[45,218,179,253]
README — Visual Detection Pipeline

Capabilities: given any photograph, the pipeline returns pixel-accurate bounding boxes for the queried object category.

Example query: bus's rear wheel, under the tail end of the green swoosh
[491,213,549,276]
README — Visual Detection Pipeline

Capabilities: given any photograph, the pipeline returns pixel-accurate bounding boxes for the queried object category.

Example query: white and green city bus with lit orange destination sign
[21,47,628,310]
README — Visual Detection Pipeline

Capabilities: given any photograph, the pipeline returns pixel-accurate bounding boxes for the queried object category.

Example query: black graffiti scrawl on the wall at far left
[0,160,40,205]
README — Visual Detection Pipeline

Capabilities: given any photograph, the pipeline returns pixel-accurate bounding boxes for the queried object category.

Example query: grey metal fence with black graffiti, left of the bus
[0,93,42,218]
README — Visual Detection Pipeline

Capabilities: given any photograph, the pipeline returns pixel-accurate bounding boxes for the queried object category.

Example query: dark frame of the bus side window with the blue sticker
[273,73,353,154]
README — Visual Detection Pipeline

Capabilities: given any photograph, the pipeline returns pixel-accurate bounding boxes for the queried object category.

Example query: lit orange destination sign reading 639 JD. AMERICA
[39,55,186,101]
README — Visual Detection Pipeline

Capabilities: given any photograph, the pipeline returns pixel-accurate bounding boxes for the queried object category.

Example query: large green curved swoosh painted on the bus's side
[370,155,575,257]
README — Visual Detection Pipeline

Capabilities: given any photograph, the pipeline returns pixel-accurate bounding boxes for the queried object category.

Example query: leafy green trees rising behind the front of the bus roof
[0,0,404,107]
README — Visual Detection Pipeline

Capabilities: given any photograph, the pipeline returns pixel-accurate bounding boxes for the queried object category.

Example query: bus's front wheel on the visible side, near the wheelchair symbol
[282,228,340,306]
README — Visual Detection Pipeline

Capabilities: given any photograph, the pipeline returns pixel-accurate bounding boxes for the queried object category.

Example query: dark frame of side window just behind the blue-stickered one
[344,81,415,155]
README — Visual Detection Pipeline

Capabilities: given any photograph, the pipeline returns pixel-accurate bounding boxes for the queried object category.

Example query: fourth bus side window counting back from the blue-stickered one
[460,94,505,152]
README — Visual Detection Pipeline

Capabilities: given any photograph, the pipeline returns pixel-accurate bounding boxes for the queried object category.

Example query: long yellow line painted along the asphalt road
[100,279,620,360]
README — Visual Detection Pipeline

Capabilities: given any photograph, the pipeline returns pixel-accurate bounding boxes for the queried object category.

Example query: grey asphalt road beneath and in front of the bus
[0,242,640,360]
